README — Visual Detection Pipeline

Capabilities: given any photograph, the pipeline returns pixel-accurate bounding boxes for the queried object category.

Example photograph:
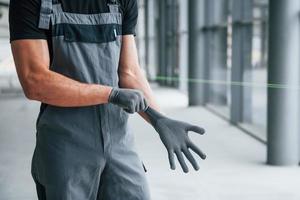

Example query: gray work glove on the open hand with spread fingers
[145,107,206,173]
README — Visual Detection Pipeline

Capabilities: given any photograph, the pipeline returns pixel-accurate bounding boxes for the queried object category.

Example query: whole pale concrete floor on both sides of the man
[0,88,300,200]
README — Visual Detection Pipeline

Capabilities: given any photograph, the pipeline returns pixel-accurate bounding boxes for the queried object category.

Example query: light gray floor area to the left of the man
[0,98,38,200]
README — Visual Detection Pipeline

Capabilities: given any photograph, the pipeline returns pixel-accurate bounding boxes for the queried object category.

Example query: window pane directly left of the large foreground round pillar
[241,2,268,140]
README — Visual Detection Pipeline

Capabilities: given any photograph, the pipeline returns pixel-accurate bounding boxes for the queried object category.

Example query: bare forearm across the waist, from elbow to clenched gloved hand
[24,70,111,107]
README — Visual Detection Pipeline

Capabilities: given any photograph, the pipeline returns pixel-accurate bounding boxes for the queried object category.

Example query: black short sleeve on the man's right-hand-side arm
[122,0,138,35]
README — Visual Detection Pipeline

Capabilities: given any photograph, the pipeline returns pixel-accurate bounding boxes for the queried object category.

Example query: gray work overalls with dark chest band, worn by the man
[32,0,150,200]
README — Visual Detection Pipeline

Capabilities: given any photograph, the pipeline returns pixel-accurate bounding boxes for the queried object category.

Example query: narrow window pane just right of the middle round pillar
[203,1,231,118]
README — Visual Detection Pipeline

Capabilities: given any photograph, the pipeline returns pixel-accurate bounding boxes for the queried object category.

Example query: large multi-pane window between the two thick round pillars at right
[203,0,268,141]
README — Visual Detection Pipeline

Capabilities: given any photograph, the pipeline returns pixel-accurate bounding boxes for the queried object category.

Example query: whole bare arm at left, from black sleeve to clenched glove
[11,40,111,107]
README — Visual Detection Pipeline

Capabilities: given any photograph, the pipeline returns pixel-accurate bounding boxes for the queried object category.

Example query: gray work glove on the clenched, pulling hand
[108,88,148,114]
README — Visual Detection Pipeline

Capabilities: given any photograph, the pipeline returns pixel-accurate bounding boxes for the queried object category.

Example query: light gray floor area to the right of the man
[137,89,300,200]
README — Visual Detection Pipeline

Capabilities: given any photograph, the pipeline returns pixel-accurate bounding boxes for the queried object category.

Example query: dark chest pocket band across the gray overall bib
[61,24,121,43]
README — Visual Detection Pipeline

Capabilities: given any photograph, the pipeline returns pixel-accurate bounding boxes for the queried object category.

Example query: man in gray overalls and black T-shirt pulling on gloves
[10,0,205,200]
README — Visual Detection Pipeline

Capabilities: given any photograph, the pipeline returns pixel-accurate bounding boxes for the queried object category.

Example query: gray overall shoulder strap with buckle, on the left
[39,0,53,29]
